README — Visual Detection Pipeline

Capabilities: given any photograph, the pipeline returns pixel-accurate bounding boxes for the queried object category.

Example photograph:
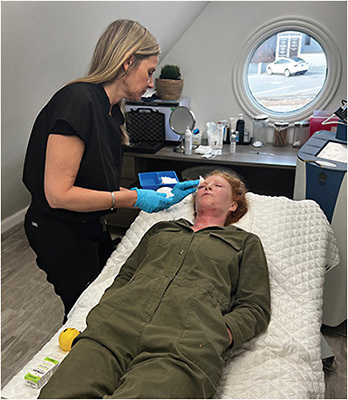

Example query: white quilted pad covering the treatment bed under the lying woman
[2,189,339,399]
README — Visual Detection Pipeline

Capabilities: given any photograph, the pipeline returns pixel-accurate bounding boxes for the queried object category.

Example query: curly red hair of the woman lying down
[194,169,248,226]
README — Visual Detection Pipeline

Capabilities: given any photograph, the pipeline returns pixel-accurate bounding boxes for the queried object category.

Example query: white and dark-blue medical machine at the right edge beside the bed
[294,105,347,326]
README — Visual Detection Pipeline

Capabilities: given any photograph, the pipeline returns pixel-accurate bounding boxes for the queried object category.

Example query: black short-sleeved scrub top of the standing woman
[23,82,124,221]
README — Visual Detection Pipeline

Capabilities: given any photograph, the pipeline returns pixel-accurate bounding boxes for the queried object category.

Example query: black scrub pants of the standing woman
[24,204,113,317]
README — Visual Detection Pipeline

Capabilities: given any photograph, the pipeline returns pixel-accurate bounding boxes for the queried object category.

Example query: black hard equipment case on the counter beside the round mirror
[124,108,165,153]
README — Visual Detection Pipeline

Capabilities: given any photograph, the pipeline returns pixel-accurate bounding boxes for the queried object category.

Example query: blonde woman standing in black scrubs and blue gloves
[23,20,197,322]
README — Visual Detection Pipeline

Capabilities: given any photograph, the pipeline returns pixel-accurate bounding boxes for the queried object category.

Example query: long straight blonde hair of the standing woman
[70,19,160,144]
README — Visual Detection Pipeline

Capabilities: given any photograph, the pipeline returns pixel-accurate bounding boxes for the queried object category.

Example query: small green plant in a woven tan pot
[156,65,184,100]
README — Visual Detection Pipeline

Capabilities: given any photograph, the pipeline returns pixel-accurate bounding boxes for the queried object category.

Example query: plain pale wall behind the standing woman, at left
[1,1,208,231]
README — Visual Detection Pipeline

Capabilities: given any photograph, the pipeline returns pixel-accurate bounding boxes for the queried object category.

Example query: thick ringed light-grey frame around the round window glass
[232,16,342,123]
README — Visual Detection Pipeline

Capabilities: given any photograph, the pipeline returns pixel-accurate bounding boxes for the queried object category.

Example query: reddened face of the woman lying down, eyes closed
[195,175,237,216]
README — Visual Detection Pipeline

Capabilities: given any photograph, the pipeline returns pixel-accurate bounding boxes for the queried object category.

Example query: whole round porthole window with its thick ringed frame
[233,18,341,122]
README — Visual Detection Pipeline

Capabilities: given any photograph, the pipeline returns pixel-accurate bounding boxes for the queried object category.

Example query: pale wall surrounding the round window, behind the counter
[158,1,347,134]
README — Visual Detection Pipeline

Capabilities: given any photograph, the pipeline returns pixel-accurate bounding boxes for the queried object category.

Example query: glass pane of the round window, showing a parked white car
[247,31,327,113]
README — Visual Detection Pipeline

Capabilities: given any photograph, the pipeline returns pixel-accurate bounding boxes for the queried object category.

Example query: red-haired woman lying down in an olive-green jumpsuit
[40,171,270,399]
